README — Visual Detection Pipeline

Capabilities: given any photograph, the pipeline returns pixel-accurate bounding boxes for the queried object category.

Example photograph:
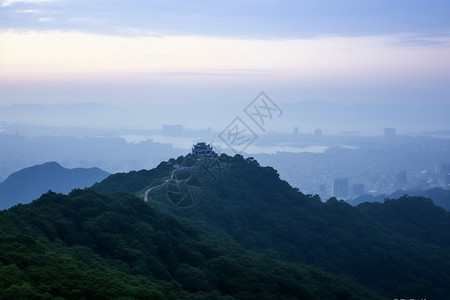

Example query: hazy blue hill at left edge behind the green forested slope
[0,162,110,209]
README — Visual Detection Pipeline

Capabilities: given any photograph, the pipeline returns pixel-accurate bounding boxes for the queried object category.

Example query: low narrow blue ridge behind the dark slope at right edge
[348,188,450,211]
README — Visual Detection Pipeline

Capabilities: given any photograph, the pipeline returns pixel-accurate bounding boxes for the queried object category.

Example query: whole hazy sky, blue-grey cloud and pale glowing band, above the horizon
[0,0,450,105]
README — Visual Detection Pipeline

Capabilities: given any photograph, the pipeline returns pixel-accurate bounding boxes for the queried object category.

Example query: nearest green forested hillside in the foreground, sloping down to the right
[0,190,381,299]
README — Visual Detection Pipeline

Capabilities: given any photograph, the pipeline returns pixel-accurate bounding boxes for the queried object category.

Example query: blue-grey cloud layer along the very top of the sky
[0,0,450,39]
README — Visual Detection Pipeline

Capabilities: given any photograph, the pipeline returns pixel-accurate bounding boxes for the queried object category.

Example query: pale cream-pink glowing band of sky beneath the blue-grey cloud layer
[0,31,450,101]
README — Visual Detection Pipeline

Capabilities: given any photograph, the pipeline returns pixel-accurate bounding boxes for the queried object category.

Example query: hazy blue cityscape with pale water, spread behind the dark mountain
[0,124,450,200]
